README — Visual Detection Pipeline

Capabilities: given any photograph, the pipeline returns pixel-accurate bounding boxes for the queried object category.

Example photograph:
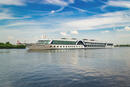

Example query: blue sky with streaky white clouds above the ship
[0,0,130,44]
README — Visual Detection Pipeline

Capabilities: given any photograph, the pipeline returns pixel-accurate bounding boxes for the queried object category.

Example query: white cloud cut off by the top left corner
[0,0,24,5]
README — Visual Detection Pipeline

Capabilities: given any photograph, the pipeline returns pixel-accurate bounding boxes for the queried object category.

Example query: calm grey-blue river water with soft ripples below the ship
[0,47,130,87]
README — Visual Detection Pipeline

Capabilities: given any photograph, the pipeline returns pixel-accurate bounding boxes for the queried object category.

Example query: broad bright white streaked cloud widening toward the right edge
[63,11,130,30]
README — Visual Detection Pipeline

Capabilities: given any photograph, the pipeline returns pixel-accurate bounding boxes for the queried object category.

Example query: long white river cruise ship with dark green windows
[27,38,114,50]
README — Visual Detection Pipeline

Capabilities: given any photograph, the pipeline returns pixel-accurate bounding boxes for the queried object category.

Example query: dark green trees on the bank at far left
[0,42,26,49]
